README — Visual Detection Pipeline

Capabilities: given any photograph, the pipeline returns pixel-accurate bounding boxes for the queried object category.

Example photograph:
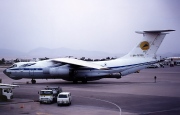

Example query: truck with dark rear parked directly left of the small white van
[39,87,62,103]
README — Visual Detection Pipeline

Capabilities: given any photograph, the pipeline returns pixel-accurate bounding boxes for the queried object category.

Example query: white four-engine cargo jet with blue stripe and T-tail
[3,30,175,84]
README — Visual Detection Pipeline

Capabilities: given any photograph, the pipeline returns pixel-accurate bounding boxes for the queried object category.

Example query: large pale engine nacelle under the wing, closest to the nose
[49,67,70,76]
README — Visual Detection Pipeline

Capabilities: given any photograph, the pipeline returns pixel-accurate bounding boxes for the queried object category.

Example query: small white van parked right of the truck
[57,92,72,106]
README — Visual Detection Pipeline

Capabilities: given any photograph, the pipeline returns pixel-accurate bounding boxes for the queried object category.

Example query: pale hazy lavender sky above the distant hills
[0,0,180,53]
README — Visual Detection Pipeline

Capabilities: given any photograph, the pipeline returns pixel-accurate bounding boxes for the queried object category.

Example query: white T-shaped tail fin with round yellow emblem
[125,30,175,58]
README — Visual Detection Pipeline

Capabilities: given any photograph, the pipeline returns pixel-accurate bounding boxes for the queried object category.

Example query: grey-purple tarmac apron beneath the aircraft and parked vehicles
[0,66,180,115]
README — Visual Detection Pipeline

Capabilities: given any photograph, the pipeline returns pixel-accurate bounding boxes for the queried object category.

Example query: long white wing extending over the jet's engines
[52,58,108,70]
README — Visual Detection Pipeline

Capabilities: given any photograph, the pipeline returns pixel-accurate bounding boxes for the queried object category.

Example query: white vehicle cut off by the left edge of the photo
[0,83,19,101]
